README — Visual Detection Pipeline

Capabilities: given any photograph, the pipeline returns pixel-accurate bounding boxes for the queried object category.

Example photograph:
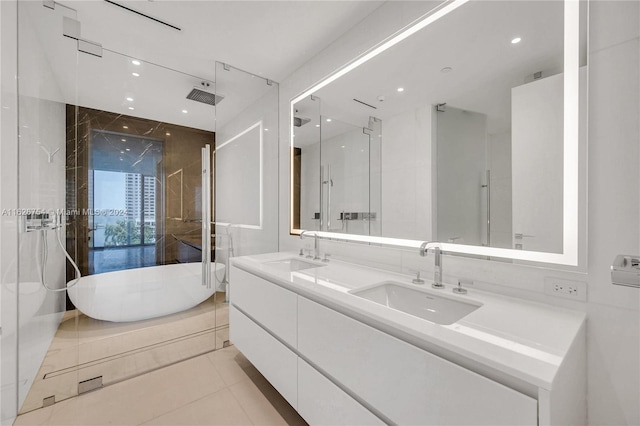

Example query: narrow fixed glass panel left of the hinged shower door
[15,2,80,414]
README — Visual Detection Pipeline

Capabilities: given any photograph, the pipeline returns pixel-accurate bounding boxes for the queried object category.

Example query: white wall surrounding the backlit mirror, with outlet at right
[280,0,640,425]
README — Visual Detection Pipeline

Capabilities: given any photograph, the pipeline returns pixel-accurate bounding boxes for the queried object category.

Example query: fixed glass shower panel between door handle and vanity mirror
[214,63,278,347]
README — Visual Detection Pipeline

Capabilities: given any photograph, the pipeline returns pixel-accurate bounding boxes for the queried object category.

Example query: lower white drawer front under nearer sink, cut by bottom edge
[298,358,384,426]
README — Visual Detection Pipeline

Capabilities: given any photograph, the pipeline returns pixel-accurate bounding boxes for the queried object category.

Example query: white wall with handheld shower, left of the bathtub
[0,2,66,424]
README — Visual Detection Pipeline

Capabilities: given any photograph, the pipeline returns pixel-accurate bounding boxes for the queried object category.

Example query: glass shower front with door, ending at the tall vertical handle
[13,2,219,413]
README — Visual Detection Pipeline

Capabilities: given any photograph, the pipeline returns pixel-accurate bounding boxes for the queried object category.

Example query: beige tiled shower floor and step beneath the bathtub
[20,293,229,413]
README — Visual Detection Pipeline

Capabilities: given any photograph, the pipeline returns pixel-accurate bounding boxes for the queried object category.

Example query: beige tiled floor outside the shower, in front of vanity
[15,346,306,426]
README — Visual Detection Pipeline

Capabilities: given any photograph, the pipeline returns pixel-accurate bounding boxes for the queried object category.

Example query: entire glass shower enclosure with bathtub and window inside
[1,2,280,421]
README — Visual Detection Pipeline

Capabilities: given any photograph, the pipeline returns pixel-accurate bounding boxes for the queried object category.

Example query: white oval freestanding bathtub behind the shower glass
[67,262,224,322]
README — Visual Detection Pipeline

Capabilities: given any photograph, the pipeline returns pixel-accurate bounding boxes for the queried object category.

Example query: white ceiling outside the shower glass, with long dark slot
[60,0,382,81]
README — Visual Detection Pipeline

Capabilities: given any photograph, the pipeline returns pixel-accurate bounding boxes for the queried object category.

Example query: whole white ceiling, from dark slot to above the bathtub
[19,0,382,130]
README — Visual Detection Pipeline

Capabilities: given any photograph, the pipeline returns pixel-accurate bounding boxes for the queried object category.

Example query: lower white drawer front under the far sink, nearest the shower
[229,305,298,408]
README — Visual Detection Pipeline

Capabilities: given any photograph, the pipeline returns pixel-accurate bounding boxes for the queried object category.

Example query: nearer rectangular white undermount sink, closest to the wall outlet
[351,281,482,325]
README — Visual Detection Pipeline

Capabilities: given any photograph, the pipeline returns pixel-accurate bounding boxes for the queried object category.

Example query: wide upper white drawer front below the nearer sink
[298,297,538,425]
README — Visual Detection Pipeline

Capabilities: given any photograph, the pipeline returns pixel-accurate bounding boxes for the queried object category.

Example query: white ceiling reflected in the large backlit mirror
[295,1,580,146]
